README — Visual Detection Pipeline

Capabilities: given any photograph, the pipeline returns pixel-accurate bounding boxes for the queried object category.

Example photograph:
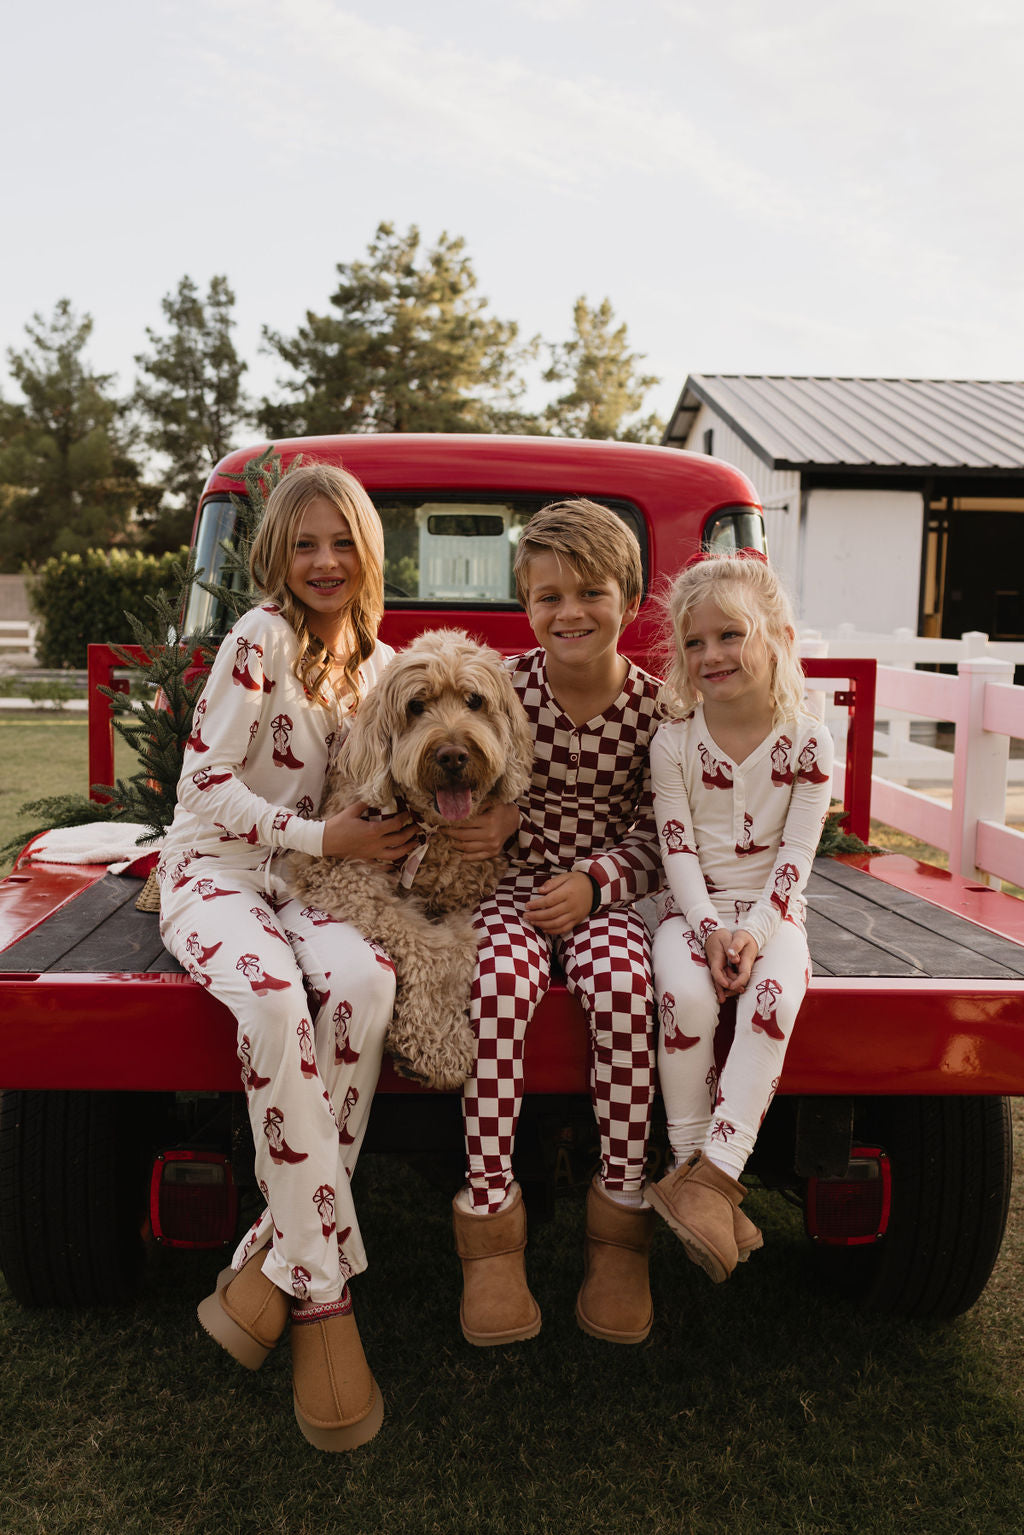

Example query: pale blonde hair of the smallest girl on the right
[659,554,806,729]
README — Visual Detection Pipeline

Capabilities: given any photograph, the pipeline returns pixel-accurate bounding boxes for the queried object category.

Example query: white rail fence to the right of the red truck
[800,628,1024,887]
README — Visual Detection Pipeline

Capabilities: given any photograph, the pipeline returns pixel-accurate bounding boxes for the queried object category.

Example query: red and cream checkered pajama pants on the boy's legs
[462,869,654,1211]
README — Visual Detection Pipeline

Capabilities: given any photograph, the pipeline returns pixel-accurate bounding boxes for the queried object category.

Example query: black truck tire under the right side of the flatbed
[815,1098,1013,1319]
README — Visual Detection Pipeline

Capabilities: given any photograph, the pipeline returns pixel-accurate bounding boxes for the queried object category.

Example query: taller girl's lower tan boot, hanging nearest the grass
[292,1289,384,1451]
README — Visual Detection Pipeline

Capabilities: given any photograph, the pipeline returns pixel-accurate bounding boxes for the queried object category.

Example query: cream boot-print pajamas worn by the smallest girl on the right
[651,705,832,1177]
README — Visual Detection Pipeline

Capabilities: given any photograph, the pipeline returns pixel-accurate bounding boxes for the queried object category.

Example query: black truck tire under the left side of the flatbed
[0,1090,146,1306]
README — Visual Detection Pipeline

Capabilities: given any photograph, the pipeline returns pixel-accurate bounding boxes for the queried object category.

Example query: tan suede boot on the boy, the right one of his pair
[576,1177,654,1343]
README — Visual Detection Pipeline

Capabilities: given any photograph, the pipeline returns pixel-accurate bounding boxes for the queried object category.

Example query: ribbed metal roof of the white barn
[663,373,1024,474]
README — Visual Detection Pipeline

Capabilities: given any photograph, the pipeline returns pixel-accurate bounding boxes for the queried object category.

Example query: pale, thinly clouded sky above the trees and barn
[8,0,1024,432]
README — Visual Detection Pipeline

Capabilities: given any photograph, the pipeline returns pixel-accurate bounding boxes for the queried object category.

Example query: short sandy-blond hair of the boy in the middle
[513,496,643,608]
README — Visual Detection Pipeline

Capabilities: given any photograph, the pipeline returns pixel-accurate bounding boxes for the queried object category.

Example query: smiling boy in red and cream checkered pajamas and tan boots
[453,500,662,1345]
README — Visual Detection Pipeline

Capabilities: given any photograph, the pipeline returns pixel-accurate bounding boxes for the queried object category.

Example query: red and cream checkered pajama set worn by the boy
[462,649,663,1214]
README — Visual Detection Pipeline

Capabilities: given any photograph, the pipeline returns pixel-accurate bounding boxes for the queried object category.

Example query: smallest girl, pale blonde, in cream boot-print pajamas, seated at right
[643,551,832,1282]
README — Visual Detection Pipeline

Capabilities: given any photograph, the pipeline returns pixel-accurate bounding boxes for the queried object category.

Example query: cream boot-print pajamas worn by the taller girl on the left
[158,605,395,1302]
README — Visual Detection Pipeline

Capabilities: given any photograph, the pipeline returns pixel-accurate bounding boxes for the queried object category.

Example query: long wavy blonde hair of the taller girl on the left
[249,464,384,705]
